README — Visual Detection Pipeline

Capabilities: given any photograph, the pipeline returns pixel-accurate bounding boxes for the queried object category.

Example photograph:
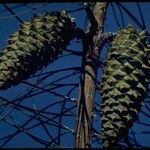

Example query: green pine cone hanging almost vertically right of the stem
[101,25,150,148]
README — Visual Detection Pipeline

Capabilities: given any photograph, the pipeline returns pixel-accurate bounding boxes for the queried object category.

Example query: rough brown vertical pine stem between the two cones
[75,2,107,148]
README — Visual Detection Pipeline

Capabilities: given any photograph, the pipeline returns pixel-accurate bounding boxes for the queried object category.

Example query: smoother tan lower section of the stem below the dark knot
[76,66,95,148]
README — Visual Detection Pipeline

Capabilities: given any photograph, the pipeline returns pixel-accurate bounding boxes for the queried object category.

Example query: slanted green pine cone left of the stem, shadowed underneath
[0,11,76,90]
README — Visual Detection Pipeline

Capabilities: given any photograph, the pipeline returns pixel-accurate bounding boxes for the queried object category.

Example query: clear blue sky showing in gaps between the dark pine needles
[0,2,150,148]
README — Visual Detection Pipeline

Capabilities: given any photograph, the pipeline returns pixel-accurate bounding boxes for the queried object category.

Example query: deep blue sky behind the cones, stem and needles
[0,2,150,148]
